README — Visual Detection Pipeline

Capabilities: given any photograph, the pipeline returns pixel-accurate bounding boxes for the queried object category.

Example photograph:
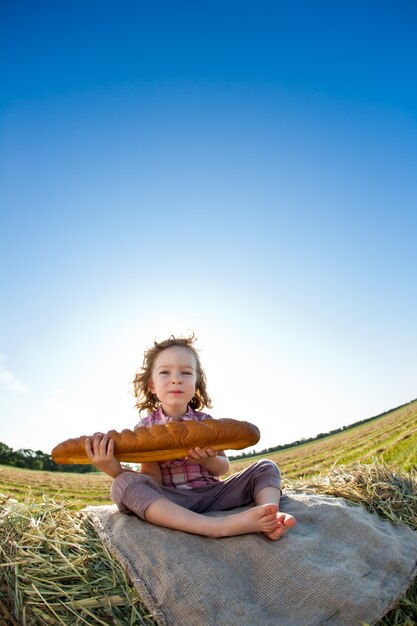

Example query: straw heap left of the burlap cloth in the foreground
[0,495,154,626]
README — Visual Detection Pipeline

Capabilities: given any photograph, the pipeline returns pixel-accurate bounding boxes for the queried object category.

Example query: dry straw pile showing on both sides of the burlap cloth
[0,462,417,626]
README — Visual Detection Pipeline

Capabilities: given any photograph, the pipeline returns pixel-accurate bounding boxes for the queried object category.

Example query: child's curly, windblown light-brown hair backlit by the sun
[133,333,212,413]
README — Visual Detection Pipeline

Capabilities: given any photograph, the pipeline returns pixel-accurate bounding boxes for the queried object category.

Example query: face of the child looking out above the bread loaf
[149,346,197,418]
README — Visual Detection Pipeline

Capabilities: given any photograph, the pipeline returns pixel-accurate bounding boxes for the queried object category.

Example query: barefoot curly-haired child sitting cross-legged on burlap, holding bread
[86,335,296,540]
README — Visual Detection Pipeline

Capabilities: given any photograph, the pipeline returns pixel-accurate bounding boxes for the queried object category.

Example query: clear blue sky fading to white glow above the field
[0,0,417,452]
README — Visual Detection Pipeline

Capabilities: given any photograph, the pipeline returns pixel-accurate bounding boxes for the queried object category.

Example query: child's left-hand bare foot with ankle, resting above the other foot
[220,503,278,538]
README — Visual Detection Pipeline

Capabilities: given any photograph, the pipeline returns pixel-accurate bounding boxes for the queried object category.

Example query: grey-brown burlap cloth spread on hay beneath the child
[87,493,417,626]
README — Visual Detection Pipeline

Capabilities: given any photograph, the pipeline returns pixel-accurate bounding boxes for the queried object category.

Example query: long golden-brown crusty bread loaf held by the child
[52,419,260,465]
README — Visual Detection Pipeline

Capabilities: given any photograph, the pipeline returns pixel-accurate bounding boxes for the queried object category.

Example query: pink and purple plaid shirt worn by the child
[135,406,220,489]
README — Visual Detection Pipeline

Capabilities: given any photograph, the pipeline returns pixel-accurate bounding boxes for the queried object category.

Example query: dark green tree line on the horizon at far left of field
[0,441,98,474]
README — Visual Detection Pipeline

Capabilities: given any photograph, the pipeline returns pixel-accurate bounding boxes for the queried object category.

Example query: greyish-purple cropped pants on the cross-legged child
[111,459,281,519]
